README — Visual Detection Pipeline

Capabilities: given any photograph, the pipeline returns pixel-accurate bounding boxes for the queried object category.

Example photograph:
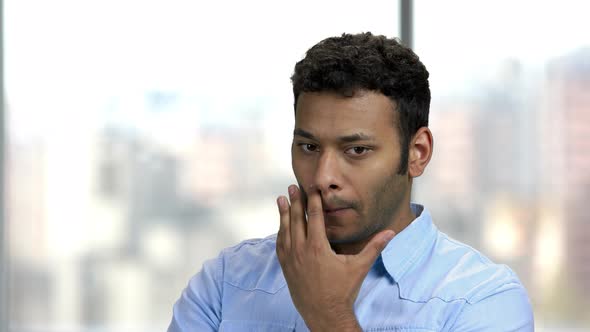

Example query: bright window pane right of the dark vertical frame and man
[414,0,590,331]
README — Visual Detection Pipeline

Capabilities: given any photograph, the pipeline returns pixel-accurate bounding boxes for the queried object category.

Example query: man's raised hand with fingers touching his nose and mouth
[276,185,395,331]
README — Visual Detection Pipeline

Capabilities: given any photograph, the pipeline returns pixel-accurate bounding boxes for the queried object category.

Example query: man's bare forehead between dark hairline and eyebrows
[295,91,397,139]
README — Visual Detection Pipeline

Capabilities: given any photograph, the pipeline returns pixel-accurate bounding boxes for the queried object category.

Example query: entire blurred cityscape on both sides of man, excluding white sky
[7,48,590,331]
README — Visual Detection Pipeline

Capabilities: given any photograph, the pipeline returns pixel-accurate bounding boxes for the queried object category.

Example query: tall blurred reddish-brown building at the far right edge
[539,48,590,305]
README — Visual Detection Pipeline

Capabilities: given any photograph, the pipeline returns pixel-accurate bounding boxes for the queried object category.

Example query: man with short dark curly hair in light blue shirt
[169,33,533,331]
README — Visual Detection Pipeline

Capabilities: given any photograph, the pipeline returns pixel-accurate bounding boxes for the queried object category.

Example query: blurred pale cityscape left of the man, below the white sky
[7,92,292,331]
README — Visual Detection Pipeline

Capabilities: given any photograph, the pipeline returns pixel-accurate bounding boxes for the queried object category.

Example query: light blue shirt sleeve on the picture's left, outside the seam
[168,255,223,332]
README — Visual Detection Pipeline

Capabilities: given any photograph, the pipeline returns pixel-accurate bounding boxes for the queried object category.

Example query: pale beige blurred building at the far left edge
[6,139,53,325]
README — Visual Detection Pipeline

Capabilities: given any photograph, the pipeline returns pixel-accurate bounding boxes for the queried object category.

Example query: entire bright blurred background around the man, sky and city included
[0,0,590,332]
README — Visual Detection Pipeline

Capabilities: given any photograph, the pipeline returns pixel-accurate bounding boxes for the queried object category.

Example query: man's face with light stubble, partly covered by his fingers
[291,91,411,244]
